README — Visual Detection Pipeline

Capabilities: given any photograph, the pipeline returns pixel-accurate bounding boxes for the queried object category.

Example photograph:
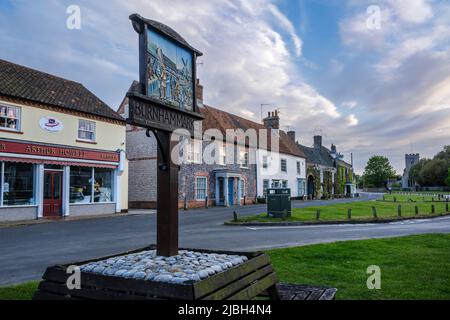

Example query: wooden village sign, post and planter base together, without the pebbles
[34,14,279,300]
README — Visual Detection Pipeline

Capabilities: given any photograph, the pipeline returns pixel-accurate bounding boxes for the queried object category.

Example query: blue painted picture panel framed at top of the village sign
[147,29,194,111]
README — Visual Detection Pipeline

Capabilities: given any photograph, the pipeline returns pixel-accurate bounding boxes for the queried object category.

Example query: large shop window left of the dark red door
[2,162,35,206]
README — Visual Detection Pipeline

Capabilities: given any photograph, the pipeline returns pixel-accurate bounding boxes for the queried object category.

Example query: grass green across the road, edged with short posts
[234,201,446,222]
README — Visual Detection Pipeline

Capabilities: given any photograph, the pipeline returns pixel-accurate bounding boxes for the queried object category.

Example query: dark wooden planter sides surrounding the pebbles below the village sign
[33,245,279,301]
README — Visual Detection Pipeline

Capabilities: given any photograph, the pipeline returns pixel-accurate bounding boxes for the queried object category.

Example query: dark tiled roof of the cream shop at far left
[0,59,124,121]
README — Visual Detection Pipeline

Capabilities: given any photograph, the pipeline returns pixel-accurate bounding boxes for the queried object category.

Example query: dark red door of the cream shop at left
[44,171,62,217]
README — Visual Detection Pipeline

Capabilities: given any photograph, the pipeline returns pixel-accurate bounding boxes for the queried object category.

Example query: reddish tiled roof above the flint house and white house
[200,105,305,158]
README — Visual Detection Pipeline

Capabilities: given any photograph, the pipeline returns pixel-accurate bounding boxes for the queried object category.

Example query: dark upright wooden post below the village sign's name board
[156,131,179,257]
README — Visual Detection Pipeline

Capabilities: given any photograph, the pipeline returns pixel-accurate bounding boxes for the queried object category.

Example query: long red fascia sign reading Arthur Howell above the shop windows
[0,140,120,162]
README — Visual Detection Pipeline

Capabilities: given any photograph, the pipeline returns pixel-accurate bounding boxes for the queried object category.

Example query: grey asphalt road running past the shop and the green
[0,195,450,286]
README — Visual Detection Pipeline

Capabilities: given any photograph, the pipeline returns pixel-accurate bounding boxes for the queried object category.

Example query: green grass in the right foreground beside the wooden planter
[268,234,450,300]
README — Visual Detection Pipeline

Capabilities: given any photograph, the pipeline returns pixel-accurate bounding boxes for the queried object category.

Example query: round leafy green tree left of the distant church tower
[364,156,396,188]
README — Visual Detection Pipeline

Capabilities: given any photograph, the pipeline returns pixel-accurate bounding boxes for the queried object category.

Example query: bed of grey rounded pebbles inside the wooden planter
[80,250,248,284]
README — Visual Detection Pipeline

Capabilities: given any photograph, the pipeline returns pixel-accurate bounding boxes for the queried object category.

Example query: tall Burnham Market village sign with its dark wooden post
[127,14,203,256]
